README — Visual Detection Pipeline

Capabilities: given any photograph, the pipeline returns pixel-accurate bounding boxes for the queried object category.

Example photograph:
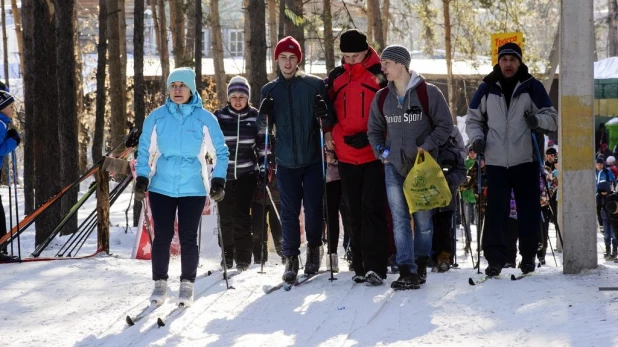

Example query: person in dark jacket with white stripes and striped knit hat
[214,76,266,271]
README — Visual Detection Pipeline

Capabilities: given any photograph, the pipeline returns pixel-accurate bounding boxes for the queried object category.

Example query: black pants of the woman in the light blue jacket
[148,192,206,282]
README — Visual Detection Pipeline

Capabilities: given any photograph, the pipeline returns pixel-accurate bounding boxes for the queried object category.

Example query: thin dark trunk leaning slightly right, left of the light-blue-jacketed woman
[92,0,107,163]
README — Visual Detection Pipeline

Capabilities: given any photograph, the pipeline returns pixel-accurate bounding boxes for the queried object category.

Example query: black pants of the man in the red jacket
[339,160,388,277]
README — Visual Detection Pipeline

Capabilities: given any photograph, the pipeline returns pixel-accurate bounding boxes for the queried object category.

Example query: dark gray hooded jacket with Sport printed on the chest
[367,71,453,176]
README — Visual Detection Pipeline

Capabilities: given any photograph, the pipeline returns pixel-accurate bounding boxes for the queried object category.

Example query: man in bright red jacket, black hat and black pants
[324,29,388,285]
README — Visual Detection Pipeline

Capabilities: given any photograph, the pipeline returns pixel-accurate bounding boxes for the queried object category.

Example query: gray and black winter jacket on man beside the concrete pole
[466,64,557,168]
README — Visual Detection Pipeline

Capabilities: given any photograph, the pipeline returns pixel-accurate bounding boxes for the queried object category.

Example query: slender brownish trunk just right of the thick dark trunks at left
[73,7,90,172]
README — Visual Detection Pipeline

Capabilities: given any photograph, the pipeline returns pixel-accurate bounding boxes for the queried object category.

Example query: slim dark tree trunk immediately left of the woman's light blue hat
[133,0,143,226]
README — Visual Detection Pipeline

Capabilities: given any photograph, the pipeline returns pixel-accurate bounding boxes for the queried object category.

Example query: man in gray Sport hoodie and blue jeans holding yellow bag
[367,45,453,290]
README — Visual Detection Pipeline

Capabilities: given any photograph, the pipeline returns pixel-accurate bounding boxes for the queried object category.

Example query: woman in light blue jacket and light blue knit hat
[135,67,229,306]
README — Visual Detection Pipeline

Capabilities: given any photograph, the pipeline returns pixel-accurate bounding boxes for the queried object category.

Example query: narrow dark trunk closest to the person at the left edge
[21,0,36,215]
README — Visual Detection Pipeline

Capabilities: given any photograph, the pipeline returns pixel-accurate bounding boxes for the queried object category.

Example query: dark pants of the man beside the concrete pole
[483,162,541,265]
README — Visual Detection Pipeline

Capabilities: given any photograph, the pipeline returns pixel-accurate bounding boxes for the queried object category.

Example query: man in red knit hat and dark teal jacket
[260,36,327,282]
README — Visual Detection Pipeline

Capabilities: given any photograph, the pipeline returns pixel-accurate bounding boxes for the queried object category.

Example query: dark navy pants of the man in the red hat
[277,162,324,257]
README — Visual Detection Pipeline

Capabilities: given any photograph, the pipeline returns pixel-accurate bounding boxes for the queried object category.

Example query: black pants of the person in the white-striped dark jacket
[218,172,257,265]
